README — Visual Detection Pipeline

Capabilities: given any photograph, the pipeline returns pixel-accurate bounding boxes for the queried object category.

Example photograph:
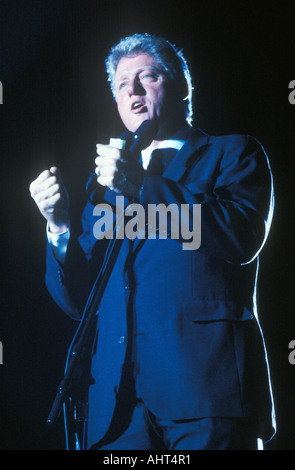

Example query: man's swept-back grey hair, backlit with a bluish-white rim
[105,33,193,124]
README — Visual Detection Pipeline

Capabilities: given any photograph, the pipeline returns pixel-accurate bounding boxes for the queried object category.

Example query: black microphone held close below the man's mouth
[86,119,158,205]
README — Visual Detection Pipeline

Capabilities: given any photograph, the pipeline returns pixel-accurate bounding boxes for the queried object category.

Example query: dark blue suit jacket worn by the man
[46,128,273,446]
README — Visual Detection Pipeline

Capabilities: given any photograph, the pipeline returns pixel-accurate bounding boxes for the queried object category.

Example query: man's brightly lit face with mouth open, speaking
[115,54,175,136]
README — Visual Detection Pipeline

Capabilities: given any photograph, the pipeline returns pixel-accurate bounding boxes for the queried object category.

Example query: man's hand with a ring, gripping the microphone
[95,144,145,198]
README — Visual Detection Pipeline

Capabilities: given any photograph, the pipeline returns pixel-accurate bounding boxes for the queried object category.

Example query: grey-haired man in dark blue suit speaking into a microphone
[30,34,274,450]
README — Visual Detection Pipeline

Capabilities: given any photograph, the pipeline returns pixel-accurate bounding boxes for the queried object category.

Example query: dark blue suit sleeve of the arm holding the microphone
[140,135,273,264]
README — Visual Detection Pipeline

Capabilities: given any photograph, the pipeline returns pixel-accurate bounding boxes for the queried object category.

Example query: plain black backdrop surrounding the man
[0,0,295,450]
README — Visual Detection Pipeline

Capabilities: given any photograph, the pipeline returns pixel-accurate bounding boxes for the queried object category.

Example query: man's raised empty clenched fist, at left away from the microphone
[30,167,69,233]
